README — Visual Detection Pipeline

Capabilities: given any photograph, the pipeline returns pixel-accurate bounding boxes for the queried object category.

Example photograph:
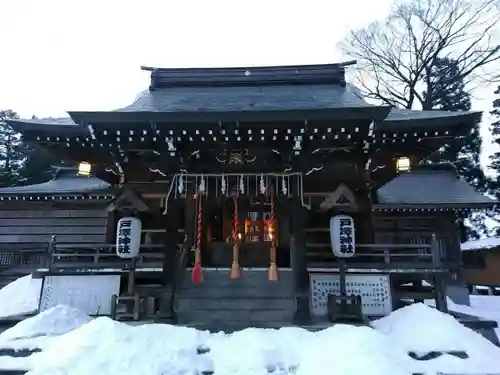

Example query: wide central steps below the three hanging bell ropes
[176,269,295,330]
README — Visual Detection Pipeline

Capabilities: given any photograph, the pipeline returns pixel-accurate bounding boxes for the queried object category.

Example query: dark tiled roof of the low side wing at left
[0,169,112,196]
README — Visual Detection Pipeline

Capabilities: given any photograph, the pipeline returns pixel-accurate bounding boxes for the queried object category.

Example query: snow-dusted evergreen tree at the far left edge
[0,110,24,187]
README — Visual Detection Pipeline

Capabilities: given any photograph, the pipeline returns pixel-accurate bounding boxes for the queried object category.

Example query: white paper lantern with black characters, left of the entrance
[116,217,142,259]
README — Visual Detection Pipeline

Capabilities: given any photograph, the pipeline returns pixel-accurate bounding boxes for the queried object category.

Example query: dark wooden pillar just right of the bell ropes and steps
[290,197,311,324]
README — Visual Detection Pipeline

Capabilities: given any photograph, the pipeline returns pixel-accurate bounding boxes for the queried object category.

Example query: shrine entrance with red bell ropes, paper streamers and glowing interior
[171,174,301,278]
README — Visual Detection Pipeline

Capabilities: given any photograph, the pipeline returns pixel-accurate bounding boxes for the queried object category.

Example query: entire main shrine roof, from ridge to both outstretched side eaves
[4,62,480,129]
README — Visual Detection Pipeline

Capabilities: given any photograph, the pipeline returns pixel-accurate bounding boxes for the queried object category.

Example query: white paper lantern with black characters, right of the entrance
[330,215,356,258]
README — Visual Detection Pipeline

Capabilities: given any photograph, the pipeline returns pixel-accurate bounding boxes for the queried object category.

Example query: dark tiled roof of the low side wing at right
[377,165,496,208]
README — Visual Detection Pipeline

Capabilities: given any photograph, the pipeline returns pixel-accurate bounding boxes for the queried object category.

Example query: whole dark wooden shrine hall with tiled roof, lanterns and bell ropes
[0,63,495,326]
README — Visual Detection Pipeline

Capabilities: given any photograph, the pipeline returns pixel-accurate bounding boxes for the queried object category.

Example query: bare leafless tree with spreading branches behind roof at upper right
[341,0,500,109]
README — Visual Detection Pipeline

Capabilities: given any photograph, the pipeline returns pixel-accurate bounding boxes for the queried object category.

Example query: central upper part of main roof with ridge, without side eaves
[113,63,373,116]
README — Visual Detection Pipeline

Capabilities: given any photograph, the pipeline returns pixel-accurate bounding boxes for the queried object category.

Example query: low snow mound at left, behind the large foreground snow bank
[0,305,92,341]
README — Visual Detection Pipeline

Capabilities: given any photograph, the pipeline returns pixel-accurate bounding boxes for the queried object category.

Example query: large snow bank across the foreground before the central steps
[25,318,414,375]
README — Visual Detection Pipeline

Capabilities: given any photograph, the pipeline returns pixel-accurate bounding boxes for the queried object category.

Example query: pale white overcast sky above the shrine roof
[0,0,498,170]
